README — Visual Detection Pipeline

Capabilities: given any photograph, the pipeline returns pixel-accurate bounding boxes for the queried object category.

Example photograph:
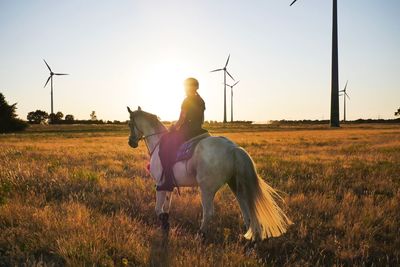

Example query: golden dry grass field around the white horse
[0,125,400,266]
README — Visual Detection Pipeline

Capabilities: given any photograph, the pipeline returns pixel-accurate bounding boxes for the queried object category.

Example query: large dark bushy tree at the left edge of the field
[0,93,28,133]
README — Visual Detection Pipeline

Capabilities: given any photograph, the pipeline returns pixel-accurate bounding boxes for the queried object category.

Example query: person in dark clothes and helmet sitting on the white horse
[157,78,206,191]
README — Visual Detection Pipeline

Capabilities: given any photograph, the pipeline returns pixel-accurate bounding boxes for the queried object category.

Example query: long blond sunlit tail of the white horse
[232,148,292,240]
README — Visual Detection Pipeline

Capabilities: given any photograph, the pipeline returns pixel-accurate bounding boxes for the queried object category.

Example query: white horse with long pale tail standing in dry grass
[128,107,291,240]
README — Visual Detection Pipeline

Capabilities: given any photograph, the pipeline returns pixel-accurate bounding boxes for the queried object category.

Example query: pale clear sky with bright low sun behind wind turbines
[0,0,400,122]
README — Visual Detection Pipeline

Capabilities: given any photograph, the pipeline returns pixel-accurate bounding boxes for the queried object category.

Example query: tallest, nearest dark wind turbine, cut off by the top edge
[290,0,340,127]
